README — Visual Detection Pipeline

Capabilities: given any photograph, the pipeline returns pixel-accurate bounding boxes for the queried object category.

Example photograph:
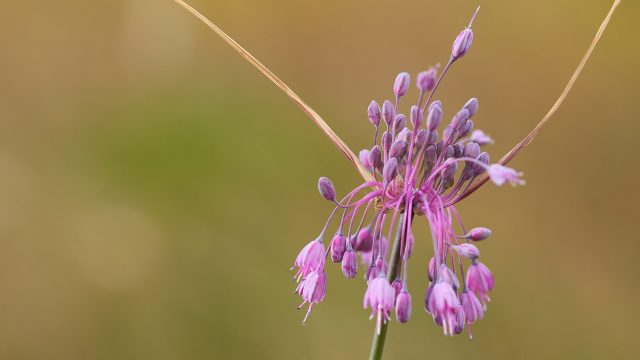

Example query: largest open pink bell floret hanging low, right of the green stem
[428,281,461,335]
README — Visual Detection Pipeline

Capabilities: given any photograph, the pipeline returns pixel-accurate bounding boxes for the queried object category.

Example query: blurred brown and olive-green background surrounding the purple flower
[0,0,640,359]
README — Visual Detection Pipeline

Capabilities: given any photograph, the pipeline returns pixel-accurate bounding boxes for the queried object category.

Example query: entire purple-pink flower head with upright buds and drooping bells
[294,6,524,335]
